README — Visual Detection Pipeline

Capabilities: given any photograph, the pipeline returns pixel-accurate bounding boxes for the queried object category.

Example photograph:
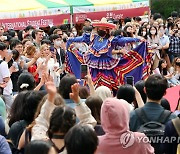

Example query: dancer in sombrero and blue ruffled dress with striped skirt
[67,18,146,90]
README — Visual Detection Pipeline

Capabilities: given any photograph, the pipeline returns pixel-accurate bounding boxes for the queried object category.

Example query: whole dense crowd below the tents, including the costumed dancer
[0,12,180,154]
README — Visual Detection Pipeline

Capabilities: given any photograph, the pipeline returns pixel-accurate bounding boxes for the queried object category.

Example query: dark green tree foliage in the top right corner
[151,0,180,18]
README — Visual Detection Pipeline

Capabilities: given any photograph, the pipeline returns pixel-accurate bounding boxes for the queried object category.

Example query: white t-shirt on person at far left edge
[0,61,13,95]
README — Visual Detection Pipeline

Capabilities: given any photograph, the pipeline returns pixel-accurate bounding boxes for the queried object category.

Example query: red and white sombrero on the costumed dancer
[92,18,116,29]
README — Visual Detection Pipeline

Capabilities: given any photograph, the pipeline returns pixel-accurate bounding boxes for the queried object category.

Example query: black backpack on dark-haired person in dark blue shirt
[135,108,171,154]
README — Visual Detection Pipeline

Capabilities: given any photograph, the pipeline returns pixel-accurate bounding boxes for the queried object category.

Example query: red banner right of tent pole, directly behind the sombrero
[73,7,149,23]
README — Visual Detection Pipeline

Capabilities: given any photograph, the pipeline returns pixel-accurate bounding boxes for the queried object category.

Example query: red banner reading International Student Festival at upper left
[0,14,70,30]
